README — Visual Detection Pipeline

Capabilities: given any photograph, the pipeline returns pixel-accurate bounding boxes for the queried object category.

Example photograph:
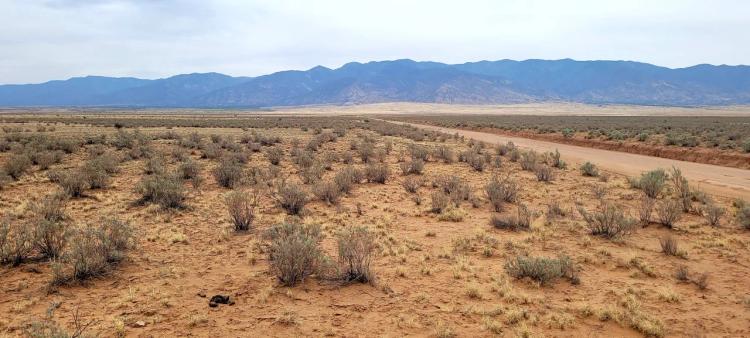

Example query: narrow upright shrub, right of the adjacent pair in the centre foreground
[337,226,376,283]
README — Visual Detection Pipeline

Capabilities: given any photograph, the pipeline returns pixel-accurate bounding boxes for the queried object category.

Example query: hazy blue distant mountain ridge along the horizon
[0,59,750,108]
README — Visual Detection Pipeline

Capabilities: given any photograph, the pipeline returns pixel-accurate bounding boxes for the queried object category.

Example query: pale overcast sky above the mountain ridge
[0,0,750,84]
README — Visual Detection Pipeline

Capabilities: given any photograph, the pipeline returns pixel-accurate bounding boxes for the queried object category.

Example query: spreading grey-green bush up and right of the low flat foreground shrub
[578,203,635,239]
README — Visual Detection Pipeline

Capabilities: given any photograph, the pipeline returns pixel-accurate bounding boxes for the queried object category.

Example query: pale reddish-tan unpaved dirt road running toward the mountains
[388,121,750,198]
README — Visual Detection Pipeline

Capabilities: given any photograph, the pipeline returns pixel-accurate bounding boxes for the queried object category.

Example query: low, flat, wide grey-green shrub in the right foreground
[505,256,580,285]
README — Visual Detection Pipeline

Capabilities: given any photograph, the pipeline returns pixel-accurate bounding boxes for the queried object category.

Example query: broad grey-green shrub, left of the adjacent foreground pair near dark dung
[267,223,324,286]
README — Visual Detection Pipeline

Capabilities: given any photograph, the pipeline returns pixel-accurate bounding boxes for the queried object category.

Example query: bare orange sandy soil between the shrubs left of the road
[0,120,750,338]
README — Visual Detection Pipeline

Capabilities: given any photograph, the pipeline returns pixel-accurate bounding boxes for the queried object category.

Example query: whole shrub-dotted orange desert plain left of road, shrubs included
[0,106,750,337]
